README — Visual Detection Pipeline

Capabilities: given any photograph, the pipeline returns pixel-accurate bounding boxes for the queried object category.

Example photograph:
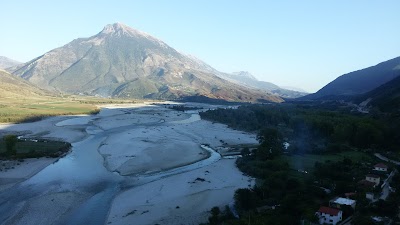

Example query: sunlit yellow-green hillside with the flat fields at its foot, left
[0,70,111,123]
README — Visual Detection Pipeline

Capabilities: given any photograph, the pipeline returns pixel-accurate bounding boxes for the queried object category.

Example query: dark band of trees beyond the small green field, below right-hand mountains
[200,104,399,152]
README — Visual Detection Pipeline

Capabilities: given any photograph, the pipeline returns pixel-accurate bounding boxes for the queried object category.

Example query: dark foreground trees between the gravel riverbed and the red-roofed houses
[203,129,324,225]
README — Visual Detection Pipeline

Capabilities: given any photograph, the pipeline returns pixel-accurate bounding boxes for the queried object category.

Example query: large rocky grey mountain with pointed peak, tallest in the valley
[9,23,282,102]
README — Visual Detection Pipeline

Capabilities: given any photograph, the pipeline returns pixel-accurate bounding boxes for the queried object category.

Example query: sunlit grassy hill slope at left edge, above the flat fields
[0,69,48,100]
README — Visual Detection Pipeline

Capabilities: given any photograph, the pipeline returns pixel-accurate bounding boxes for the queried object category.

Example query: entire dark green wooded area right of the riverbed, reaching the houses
[201,104,400,225]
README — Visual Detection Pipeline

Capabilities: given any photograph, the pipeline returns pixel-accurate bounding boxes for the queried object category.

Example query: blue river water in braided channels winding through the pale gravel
[0,108,221,225]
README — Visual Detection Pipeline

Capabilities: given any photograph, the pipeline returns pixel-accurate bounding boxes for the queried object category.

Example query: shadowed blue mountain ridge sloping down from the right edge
[302,57,400,100]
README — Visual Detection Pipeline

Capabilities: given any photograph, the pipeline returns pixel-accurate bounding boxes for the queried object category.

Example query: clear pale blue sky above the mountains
[0,0,400,92]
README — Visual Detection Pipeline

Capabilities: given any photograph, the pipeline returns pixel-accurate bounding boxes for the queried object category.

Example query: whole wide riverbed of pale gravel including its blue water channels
[0,102,257,224]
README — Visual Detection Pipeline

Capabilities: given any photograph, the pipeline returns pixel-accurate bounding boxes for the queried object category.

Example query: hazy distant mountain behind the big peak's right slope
[217,71,307,98]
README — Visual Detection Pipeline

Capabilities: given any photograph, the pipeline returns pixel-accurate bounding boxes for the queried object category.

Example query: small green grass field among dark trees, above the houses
[283,151,375,171]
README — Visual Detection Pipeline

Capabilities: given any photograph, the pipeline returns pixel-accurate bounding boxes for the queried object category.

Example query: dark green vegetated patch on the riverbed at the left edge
[0,135,71,159]
